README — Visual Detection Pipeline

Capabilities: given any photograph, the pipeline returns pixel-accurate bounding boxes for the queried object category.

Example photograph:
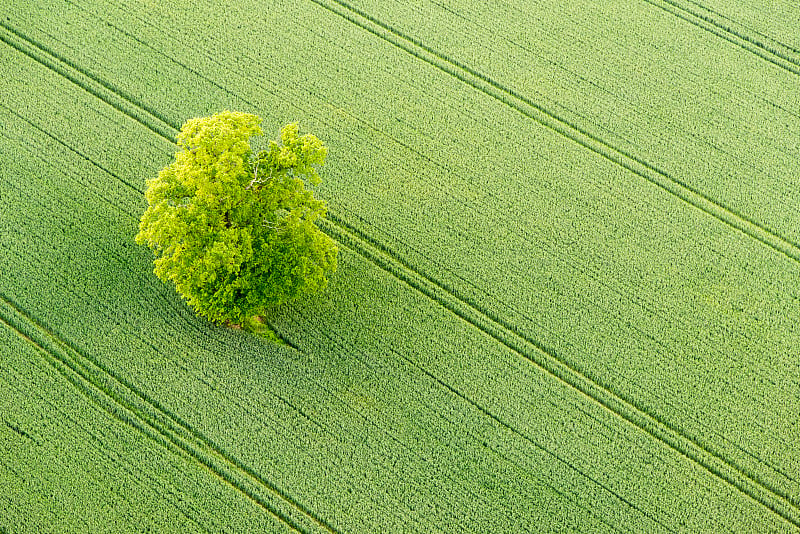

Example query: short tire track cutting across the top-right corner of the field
[644,0,800,75]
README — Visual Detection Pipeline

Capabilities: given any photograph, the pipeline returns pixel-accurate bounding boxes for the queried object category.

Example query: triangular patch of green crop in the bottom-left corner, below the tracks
[0,318,288,532]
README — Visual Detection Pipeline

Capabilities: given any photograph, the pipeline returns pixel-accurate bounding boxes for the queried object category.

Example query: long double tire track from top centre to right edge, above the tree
[309,0,800,263]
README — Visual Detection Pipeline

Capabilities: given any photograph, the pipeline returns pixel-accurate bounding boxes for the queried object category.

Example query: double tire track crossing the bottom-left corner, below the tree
[0,294,336,532]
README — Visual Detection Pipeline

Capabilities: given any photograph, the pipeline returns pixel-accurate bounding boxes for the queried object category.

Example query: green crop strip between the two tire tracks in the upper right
[326,0,800,245]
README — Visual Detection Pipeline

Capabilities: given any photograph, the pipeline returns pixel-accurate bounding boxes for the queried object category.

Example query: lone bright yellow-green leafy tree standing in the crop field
[136,111,338,333]
